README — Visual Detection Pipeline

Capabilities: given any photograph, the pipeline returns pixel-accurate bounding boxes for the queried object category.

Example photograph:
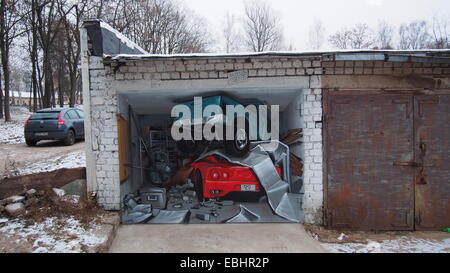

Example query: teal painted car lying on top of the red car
[175,95,270,157]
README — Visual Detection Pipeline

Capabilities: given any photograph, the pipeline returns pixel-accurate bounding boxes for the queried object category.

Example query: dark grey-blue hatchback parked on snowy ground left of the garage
[25,108,84,146]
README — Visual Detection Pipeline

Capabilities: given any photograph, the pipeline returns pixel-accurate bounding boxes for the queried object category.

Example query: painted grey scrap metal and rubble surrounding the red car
[122,138,304,224]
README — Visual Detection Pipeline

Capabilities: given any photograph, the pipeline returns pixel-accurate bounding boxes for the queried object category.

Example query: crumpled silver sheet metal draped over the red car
[196,140,303,222]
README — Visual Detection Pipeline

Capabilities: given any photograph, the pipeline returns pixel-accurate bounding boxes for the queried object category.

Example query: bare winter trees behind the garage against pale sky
[0,0,450,121]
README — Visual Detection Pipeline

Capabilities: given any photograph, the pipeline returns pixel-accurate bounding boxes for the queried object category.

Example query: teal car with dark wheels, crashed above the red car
[175,95,270,157]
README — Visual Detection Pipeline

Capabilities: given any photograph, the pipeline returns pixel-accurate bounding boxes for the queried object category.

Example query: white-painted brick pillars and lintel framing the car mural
[87,57,323,224]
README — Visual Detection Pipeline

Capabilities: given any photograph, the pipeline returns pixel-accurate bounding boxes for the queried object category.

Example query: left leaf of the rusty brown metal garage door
[326,94,414,230]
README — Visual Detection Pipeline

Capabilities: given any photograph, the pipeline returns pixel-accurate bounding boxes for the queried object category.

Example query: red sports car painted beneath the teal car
[191,156,281,202]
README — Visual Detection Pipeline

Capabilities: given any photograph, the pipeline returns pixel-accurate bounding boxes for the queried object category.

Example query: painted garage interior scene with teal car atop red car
[119,90,303,224]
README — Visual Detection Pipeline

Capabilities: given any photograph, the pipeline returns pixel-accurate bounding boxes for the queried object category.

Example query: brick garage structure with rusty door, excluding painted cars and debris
[82,21,450,230]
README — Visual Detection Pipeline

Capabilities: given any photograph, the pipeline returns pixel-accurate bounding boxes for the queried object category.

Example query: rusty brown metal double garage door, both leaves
[325,92,450,230]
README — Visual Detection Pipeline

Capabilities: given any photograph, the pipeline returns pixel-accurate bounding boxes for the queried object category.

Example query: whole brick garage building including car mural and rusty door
[81,20,450,230]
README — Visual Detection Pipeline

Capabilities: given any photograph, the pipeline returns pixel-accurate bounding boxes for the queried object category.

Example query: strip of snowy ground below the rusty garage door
[321,236,450,253]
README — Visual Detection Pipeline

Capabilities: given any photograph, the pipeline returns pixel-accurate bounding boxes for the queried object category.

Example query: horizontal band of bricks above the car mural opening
[111,56,322,81]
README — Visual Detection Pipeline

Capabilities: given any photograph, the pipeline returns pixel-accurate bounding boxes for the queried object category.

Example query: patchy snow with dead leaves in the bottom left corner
[0,217,108,253]
